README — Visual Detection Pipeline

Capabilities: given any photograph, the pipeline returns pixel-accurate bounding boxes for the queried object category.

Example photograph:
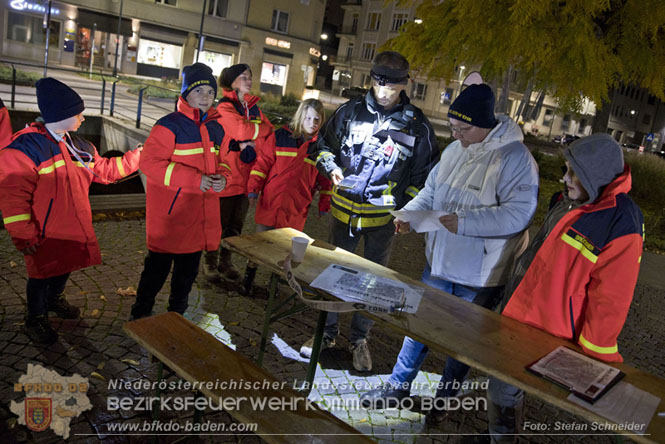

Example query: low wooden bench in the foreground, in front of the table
[122,312,374,444]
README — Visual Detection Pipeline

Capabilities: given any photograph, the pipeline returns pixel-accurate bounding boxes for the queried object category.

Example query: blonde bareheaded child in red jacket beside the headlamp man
[243,99,331,294]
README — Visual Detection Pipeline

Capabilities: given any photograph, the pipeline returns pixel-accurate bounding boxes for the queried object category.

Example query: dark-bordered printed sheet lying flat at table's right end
[527,346,624,403]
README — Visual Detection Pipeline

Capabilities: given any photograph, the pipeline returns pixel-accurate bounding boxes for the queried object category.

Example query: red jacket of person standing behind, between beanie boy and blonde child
[217,90,274,197]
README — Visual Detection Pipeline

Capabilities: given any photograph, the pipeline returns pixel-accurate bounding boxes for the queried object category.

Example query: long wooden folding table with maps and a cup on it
[223,228,665,442]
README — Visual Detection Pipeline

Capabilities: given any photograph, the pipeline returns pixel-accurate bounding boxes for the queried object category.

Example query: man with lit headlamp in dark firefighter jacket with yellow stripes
[300,51,438,371]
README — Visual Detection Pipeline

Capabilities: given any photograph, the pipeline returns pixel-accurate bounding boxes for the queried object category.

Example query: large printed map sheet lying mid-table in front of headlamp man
[310,264,425,313]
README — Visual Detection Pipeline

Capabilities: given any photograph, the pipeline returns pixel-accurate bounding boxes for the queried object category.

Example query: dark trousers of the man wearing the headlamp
[323,216,395,344]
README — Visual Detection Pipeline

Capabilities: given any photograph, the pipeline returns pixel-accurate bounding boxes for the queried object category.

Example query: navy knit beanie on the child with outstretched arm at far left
[35,77,85,123]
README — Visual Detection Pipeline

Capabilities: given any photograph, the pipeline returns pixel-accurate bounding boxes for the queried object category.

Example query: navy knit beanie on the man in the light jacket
[448,83,496,128]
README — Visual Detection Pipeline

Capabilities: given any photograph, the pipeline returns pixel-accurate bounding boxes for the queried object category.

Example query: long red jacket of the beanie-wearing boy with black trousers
[140,97,229,254]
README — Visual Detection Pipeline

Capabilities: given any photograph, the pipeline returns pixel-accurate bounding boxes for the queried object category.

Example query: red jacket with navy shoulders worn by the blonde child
[247,128,331,231]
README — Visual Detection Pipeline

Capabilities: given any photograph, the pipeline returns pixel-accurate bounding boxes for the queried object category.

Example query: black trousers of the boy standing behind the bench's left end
[132,251,201,318]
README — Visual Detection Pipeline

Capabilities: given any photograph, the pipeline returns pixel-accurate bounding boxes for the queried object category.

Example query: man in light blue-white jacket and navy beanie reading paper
[361,84,538,425]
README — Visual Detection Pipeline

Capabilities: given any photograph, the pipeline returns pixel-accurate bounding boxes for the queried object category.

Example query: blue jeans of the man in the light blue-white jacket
[388,265,503,398]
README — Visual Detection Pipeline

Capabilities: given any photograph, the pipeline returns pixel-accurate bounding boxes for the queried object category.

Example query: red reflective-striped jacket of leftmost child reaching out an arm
[0,123,139,279]
